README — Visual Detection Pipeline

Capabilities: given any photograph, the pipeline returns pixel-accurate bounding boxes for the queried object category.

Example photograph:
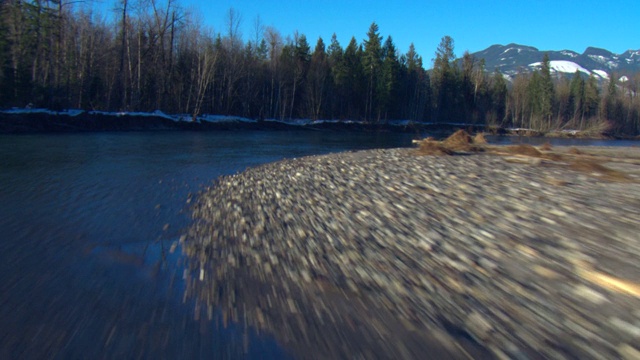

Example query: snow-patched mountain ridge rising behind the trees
[472,44,640,80]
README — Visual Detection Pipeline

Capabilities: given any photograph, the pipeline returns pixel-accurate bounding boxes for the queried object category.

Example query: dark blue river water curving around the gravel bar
[0,131,635,359]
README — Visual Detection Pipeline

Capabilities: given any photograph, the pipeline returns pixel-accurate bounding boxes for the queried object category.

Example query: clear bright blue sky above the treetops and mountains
[97,0,640,67]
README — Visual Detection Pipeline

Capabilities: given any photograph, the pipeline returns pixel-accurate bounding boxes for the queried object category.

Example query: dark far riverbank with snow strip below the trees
[0,109,637,140]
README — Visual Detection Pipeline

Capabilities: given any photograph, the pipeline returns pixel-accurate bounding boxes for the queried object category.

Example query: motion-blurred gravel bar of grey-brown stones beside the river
[181,148,640,359]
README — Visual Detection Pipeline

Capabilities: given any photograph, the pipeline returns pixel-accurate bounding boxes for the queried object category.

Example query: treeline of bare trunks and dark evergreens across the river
[0,0,640,135]
